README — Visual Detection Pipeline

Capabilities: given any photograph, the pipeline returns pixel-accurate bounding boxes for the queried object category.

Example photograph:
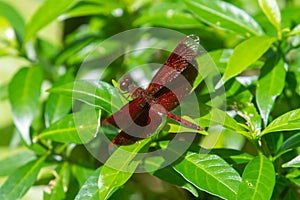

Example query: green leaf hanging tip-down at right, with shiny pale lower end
[256,57,286,126]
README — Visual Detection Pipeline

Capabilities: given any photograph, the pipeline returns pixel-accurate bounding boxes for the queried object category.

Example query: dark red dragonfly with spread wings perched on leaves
[102,35,203,145]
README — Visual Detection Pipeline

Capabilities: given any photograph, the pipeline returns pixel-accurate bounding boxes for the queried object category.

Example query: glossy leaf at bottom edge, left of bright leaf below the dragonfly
[75,167,102,200]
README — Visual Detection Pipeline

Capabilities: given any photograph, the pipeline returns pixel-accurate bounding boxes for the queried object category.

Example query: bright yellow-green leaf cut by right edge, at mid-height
[260,109,300,137]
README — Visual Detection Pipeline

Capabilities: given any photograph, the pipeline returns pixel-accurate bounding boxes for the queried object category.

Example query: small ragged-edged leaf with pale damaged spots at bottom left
[44,162,70,200]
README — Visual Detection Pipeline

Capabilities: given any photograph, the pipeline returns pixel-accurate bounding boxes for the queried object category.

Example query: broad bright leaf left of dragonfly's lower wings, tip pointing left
[37,110,101,144]
